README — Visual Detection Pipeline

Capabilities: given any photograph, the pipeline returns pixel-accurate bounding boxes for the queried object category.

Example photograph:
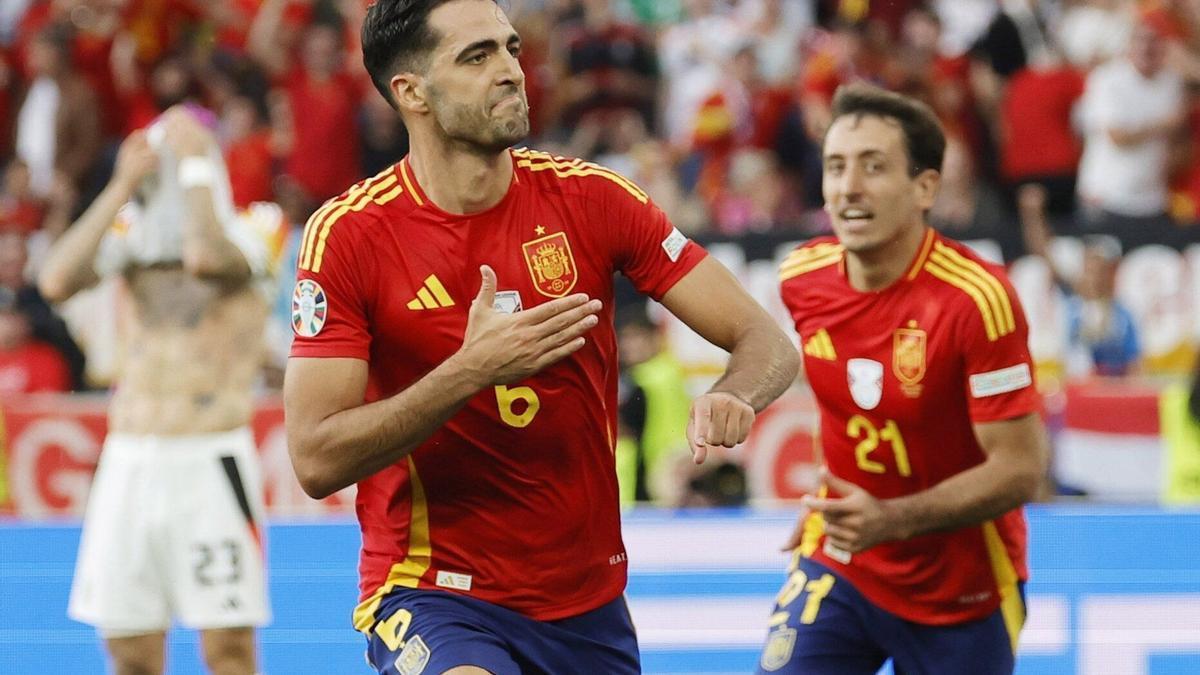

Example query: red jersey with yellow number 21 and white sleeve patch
[780,229,1040,625]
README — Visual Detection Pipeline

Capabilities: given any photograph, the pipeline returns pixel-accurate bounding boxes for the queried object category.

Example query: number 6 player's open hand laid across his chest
[455,265,602,388]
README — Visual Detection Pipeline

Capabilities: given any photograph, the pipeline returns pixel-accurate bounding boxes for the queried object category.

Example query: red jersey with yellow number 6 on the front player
[292,150,706,629]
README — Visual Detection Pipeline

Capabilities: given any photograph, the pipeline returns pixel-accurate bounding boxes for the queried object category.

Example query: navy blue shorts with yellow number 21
[758,558,1025,675]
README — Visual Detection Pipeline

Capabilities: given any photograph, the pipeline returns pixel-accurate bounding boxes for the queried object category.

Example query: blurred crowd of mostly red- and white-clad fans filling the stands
[0,0,1200,392]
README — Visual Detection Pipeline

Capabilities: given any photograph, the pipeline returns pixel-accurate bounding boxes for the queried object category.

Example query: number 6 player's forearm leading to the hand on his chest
[289,357,481,500]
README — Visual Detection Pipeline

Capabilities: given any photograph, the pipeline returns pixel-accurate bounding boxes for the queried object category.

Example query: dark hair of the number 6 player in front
[361,0,499,108]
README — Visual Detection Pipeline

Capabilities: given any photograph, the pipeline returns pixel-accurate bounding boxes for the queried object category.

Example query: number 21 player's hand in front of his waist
[800,467,900,554]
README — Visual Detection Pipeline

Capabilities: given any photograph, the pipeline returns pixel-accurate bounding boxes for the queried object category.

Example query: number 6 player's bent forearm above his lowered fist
[712,315,800,412]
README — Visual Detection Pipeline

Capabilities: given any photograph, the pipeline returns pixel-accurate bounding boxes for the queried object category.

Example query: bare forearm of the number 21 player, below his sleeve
[884,455,1042,539]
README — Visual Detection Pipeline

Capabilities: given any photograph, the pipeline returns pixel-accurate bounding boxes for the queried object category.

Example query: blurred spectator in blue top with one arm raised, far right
[1018,184,1141,377]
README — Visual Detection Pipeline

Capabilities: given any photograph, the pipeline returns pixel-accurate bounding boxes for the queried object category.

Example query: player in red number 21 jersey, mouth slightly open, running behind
[760,85,1048,675]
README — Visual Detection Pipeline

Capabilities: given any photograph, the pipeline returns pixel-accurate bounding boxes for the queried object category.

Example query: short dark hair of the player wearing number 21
[829,83,946,175]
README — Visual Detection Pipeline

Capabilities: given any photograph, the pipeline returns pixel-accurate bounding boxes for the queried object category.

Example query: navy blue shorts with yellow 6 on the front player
[367,589,642,675]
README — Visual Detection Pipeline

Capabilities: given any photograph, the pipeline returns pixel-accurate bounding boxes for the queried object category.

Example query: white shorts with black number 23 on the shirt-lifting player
[67,429,270,635]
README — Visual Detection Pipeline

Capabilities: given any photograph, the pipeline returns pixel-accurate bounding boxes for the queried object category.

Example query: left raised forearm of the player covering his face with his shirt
[37,181,133,303]
